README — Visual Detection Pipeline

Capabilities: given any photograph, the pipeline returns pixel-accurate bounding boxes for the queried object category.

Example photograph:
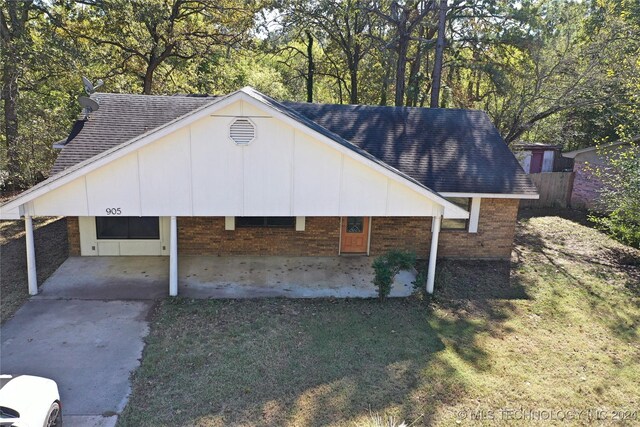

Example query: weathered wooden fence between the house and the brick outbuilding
[520,172,574,209]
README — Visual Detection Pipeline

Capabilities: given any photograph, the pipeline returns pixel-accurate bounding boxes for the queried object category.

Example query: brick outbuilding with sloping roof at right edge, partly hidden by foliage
[562,136,640,209]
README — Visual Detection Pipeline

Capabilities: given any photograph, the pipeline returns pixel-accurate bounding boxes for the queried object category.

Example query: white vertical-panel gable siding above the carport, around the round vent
[22,100,442,216]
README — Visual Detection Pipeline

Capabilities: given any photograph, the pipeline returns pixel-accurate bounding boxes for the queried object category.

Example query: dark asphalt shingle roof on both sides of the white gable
[51,93,537,194]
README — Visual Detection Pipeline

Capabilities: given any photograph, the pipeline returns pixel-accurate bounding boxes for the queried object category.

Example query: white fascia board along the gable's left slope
[0,91,241,216]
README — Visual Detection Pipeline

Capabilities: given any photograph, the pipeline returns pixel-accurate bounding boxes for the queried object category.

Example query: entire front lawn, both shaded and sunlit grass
[119,211,640,426]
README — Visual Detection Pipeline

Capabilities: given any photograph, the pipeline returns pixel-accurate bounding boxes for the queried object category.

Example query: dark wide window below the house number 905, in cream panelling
[96,216,160,240]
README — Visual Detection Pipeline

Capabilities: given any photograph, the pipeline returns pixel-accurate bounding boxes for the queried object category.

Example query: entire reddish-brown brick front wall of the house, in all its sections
[67,199,519,259]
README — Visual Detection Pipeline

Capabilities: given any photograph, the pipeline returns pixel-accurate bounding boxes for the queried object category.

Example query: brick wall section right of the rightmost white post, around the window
[438,199,520,259]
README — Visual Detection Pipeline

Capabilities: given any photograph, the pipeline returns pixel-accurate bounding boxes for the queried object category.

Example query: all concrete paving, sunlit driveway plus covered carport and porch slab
[0,257,415,427]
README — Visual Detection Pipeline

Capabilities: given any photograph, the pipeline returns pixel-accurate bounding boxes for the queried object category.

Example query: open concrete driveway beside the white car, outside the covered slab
[0,296,153,426]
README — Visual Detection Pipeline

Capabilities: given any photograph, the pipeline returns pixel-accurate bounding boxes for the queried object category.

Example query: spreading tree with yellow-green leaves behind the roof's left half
[70,0,256,94]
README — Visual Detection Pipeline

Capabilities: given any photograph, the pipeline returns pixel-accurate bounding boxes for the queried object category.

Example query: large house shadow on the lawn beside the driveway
[120,299,504,426]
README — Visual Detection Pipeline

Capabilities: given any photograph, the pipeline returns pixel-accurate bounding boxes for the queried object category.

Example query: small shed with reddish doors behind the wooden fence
[513,142,572,173]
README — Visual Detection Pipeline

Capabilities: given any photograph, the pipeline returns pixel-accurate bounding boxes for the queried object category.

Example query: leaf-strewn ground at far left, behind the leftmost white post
[0,218,68,324]
